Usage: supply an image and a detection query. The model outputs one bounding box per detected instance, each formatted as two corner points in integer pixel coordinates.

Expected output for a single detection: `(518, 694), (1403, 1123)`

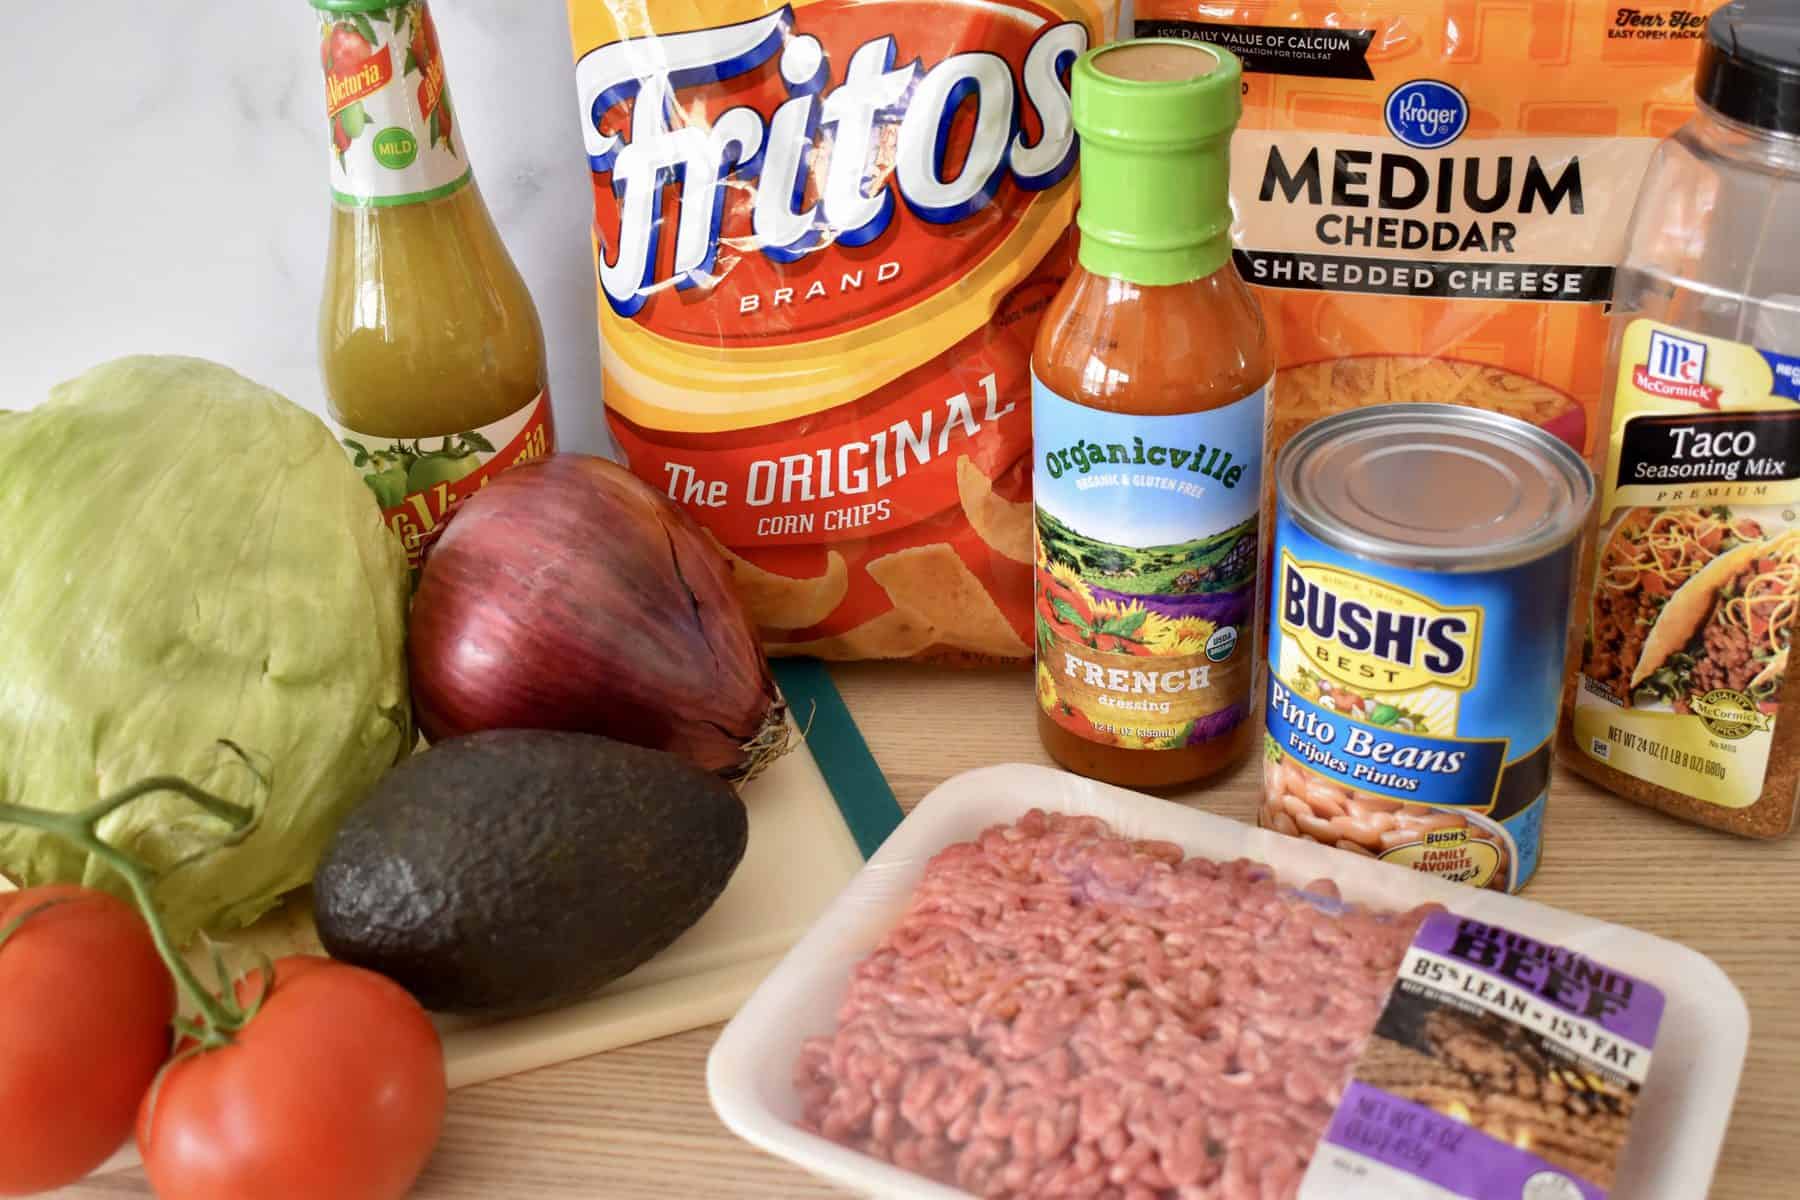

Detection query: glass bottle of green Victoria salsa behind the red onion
(313, 0), (554, 569)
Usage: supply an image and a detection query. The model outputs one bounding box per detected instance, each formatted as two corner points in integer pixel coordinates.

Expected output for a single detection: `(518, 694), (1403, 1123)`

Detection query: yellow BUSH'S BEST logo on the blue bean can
(1280, 554), (1481, 691)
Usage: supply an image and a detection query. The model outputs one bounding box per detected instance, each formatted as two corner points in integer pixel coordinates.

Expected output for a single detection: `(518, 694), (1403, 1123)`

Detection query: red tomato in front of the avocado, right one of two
(137, 957), (446, 1200)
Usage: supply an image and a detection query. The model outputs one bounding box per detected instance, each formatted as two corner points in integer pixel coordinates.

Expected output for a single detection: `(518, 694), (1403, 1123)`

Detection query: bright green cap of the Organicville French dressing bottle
(1071, 38), (1244, 286)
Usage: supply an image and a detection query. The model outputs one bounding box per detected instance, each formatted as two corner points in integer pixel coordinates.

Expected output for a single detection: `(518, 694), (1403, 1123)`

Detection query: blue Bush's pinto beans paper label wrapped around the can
(1260, 504), (1573, 891)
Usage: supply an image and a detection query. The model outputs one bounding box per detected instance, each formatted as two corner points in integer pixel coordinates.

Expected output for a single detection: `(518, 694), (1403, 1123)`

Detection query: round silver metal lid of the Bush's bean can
(1274, 405), (1593, 570)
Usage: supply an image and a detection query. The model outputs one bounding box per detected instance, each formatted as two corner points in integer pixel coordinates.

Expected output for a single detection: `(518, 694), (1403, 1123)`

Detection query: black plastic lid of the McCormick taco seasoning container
(1694, 0), (1800, 137)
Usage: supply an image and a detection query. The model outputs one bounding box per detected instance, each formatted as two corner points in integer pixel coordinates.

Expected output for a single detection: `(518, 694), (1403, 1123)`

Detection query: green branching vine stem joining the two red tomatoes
(0, 775), (266, 1045)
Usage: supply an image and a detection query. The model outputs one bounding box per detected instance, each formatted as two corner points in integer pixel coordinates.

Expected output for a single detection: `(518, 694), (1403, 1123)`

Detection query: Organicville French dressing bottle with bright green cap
(1031, 40), (1273, 788)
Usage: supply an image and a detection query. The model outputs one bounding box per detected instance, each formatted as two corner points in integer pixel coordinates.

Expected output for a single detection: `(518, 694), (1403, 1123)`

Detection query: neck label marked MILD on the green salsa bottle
(319, 0), (472, 207)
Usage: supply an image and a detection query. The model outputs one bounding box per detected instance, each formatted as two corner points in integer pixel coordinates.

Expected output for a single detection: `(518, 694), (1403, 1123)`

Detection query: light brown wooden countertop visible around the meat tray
(63, 666), (1800, 1200)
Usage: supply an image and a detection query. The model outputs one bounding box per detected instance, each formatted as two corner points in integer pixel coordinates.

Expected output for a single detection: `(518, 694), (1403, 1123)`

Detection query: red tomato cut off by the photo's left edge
(0, 885), (175, 1196)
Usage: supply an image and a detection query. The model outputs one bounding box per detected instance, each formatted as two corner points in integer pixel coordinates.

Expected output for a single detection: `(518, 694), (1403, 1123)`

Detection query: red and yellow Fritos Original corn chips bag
(569, 0), (1116, 660)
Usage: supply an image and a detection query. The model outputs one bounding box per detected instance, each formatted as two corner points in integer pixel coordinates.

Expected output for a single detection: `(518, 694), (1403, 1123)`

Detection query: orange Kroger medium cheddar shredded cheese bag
(1136, 0), (1721, 452)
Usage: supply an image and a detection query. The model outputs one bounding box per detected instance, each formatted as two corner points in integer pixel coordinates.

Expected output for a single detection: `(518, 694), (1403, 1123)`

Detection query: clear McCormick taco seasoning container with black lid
(1559, 0), (1800, 837)
